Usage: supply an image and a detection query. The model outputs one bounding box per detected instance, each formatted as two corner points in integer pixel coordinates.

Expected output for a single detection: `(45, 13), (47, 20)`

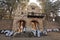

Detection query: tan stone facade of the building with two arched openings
(12, 3), (45, 31)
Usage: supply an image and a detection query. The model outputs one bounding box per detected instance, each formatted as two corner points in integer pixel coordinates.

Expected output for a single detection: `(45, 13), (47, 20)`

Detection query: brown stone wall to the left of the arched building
(0, 20), (13, 30)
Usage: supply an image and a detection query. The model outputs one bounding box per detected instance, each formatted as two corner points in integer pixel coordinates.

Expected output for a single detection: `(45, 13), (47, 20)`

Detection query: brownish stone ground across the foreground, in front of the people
(0, 32), (60, 40)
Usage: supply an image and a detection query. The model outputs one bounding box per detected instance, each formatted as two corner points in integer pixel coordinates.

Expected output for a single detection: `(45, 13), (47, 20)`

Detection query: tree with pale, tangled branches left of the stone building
(0, 0), (18, 18)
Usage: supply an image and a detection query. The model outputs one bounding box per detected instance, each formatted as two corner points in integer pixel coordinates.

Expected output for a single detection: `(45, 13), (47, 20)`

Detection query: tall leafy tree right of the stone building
(45, 0), (60, 19)
